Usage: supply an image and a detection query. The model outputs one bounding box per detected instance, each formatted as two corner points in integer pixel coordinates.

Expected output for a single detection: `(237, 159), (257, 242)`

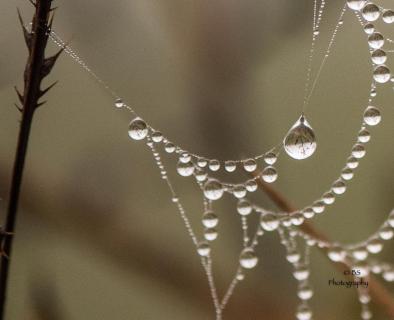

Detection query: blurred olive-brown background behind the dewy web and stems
(0, 0), (394, 320)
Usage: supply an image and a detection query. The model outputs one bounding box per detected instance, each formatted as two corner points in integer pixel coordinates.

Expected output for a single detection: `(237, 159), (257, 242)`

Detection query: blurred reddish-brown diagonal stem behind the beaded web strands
(256, 179), (394, 319)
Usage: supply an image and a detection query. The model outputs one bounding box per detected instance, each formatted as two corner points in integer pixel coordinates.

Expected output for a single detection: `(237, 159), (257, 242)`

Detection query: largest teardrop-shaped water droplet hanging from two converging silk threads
(283, 116), (316, 160)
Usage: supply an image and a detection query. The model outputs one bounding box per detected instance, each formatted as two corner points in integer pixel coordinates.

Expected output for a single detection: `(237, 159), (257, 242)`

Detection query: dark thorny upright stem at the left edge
(0, 0), (60, 320)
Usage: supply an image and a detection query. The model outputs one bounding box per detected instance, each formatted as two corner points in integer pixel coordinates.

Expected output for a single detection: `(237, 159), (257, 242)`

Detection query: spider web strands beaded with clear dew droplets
(44, 1), (393, 320)
